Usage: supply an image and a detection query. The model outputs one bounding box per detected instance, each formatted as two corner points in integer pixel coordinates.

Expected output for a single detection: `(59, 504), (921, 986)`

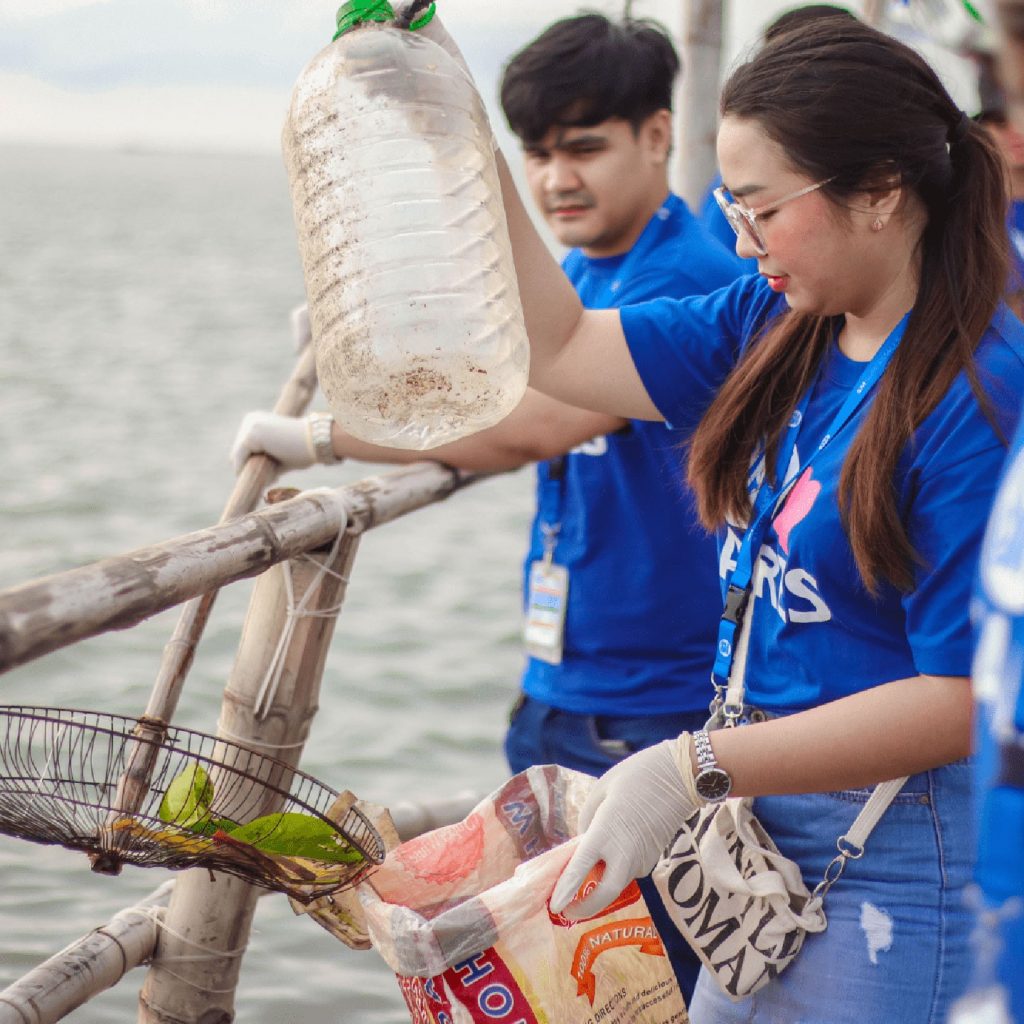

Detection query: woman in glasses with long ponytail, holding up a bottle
(475, 14), (1024, 1024)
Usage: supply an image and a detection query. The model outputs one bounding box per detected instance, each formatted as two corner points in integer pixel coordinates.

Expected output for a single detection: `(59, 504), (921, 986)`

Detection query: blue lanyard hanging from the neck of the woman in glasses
(712, 313), (910, 696)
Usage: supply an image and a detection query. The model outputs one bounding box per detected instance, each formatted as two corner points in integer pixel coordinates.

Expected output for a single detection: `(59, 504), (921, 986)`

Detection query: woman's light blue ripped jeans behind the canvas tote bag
(690, 761), (975, 1024)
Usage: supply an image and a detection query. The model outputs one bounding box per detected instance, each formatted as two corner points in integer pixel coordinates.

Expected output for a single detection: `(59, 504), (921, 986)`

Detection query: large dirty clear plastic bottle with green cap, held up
(283, 0), (528, 450)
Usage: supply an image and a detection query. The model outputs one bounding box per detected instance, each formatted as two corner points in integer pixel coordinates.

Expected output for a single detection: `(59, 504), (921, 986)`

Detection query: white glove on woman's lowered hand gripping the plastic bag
(551, 732), (705, 921)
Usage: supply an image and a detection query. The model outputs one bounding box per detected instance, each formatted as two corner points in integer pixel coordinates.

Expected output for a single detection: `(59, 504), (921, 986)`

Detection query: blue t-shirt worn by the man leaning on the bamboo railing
(522, 196), (739, 715)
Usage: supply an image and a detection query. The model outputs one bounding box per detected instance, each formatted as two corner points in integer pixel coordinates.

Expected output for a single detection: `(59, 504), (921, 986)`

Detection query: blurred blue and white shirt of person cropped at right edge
(974, 413), (1024, 1020)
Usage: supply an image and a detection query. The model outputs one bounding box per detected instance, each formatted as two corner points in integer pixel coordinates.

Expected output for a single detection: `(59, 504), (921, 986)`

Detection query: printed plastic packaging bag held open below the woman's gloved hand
(358, 765), (688, 1024)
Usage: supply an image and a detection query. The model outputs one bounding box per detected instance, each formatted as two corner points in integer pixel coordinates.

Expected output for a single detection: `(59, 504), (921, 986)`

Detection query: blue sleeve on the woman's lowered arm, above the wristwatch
(903, 347), (1024, 676)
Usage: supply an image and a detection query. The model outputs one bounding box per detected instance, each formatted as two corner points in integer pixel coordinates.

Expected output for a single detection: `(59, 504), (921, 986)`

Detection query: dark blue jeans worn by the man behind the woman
(505, 695), (712, 1005)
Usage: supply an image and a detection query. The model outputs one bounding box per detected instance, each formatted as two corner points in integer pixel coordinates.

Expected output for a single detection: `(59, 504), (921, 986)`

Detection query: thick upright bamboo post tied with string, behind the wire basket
(138, 491), (359, 1024)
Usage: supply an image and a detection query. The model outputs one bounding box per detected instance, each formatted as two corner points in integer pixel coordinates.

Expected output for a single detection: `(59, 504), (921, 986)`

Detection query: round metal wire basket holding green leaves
(0, 706), (386, 903)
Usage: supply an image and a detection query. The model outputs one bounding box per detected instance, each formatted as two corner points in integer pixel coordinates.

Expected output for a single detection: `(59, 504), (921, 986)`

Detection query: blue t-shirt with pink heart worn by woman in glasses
(622, 278), (1024, 711)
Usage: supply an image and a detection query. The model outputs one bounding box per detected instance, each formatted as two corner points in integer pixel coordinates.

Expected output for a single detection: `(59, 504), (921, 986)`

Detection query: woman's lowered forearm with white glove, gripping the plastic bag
(551, 676), (971, 920)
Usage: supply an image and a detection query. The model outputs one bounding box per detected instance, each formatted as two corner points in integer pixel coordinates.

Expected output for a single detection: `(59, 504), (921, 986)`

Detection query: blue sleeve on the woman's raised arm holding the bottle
(622, 278), (784, 434)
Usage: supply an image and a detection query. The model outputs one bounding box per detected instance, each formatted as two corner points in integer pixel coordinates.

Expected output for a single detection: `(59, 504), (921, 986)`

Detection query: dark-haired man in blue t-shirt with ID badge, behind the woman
(233, 14), (740, 997)
